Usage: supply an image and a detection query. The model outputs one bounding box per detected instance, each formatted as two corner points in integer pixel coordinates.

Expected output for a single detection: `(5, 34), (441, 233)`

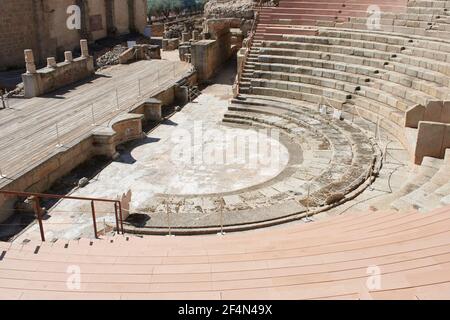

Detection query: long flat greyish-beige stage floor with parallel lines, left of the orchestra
(0, 60), (190, 187)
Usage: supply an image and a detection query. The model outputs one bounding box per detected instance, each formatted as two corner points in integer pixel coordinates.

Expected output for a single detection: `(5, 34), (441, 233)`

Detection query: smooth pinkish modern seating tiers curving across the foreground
(0, 207), (450, 299)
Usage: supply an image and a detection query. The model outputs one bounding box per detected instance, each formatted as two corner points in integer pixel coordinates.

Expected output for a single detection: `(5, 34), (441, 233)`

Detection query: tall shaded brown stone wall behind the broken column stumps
(0, 0), (147, 70)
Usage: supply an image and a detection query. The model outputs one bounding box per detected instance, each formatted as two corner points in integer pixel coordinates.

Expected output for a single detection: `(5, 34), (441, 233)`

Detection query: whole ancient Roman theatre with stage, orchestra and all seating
(0, 0), (450, 299)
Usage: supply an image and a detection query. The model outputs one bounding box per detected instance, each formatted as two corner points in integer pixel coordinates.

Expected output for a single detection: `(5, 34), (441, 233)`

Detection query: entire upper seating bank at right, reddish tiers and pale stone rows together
(236, 0), (450, 215)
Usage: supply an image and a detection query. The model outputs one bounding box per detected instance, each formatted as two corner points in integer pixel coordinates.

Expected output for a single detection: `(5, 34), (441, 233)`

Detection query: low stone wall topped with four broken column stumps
(22, 40), (95, 98)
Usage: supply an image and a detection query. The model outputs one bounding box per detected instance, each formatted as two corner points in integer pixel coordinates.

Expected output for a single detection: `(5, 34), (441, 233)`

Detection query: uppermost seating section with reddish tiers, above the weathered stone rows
(257, 1), (450, 40)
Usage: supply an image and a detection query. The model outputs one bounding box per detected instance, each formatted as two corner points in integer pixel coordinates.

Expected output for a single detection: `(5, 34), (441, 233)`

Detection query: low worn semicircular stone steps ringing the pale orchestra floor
(125, 95), (381, 233)
